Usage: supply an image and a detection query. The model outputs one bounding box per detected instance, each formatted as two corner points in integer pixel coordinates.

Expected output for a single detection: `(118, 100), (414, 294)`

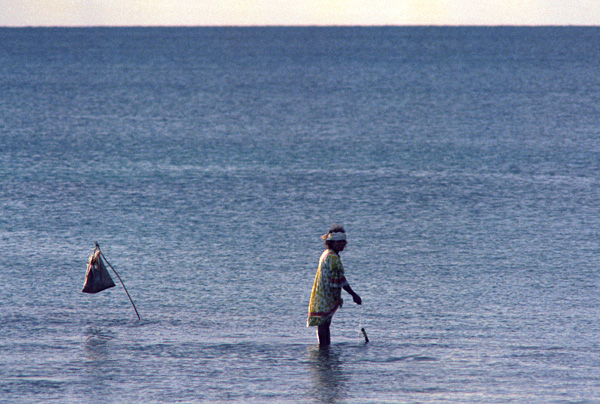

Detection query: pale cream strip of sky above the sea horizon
(0, 0), (600, 26)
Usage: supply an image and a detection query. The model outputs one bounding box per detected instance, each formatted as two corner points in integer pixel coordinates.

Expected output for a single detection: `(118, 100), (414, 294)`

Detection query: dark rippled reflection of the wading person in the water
(308, 345), (348, 403)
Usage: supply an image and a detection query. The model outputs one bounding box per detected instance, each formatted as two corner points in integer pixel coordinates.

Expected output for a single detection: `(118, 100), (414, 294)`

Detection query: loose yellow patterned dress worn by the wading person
(306, 250), (348, 326)
